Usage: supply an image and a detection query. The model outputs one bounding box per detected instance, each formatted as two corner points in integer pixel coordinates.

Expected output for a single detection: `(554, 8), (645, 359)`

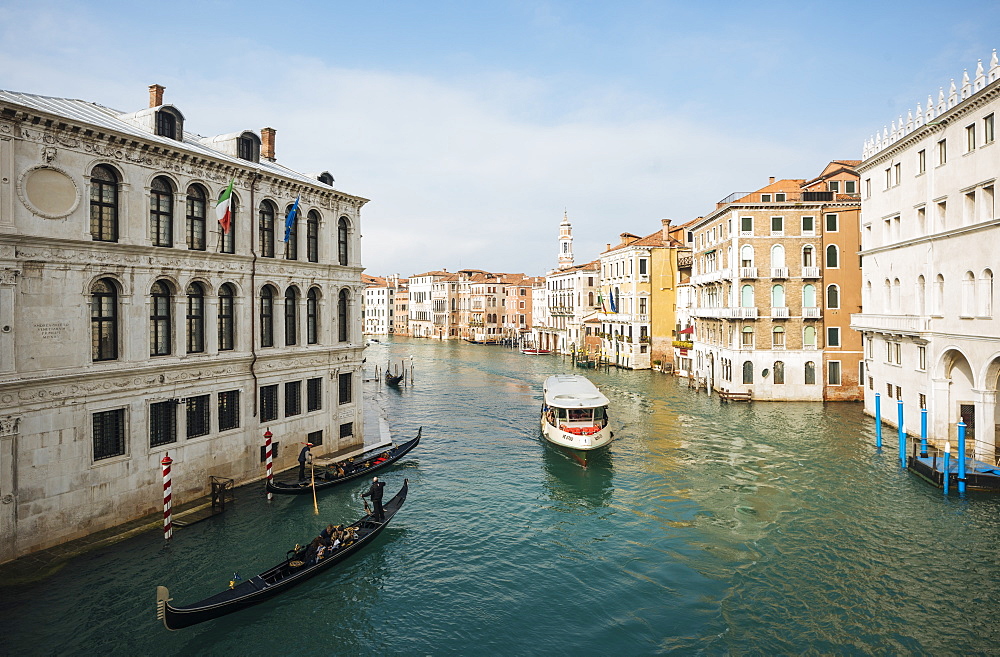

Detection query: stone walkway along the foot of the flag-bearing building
(0, 380), (392, 587)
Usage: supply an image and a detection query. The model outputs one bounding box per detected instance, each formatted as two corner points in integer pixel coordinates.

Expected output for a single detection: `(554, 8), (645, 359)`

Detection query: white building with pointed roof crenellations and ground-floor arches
(852, 51), (1000, 456)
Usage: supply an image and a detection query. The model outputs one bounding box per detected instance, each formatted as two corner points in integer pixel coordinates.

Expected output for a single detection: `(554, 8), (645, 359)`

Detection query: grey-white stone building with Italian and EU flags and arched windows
(0, 85), (366, 561)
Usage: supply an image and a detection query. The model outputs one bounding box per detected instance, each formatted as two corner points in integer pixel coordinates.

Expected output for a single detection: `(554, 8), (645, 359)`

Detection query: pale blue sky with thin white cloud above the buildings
(0, 0), (1000, 276)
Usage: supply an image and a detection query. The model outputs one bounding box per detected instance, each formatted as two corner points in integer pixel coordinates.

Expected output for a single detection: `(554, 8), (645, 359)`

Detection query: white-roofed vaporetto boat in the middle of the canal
(541, 374), (614, 465)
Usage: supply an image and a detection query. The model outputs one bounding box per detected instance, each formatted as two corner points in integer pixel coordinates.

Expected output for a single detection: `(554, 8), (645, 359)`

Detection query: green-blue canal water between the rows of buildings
(0, 340), (1000, 656)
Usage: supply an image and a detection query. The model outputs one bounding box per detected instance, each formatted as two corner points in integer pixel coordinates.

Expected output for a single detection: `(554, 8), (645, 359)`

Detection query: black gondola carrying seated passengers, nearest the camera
(156, 479), (409, 630)
